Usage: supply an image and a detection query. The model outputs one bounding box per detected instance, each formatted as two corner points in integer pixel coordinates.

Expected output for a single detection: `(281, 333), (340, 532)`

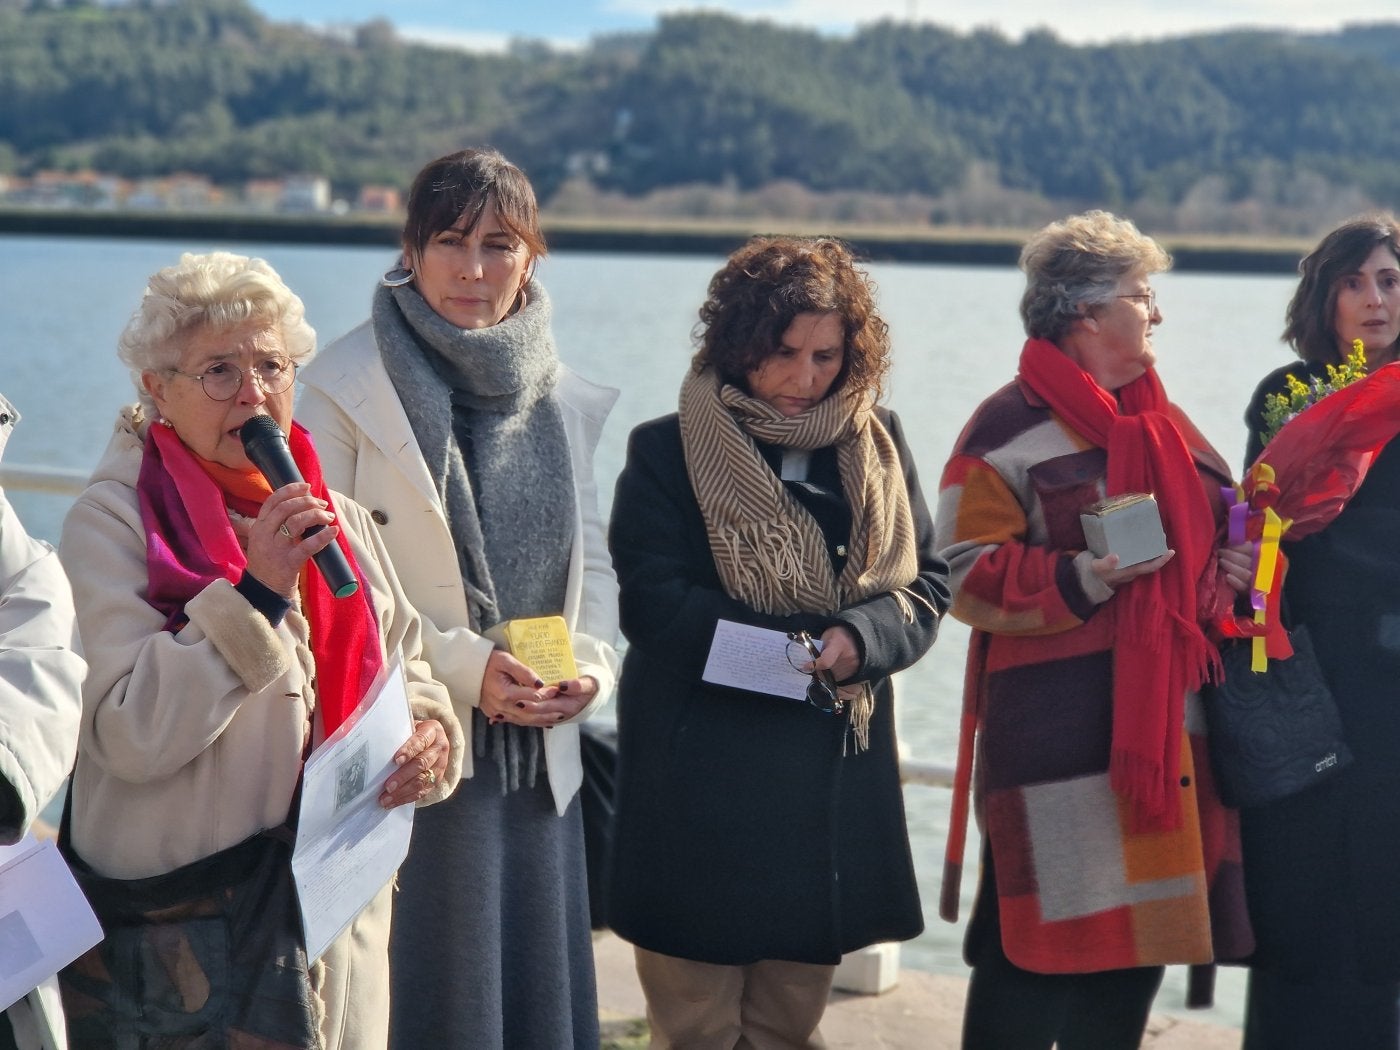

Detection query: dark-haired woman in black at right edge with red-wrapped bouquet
(1242, 216), (1400, 1050)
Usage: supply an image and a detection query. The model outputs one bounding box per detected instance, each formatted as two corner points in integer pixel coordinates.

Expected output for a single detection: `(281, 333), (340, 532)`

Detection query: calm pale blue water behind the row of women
(0, 237), (1294, 1023)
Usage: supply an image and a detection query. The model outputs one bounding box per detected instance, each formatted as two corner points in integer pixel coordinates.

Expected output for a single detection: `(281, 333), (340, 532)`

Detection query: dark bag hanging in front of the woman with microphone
(59, 806), (321, 1050)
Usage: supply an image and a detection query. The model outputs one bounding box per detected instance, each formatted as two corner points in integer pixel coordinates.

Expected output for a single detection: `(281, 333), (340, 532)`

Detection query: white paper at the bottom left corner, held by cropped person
(0, 836), (102, 1011)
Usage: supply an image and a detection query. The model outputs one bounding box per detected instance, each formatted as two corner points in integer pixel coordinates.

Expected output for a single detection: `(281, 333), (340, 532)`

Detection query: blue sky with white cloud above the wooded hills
(252, 0), (1400, 50)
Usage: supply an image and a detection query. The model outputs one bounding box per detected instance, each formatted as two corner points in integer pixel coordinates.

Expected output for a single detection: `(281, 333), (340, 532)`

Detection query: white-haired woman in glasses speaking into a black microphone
(60, 252), (461, 1050)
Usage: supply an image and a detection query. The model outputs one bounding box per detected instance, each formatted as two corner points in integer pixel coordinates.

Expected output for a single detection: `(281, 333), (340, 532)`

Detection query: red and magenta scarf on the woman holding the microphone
(136, 423), (384, 736)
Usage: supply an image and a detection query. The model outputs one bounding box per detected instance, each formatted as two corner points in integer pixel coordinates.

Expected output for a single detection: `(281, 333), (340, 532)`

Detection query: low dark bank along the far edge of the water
(0, 209), (1310, 273)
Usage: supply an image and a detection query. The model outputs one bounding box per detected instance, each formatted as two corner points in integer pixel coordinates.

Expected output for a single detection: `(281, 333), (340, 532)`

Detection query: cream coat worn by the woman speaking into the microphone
(60, 410), (465, 1050)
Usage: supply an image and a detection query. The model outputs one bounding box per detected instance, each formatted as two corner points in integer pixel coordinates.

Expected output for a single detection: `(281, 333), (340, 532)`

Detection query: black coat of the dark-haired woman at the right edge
(1240, 363), (1400, 981)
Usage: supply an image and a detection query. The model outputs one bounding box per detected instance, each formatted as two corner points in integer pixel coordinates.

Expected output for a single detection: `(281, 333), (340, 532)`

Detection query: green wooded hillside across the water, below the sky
(0, 0), (1400, 226)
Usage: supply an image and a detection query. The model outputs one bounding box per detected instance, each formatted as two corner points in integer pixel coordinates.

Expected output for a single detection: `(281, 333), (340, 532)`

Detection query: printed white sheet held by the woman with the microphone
(291, 659), (413, 962)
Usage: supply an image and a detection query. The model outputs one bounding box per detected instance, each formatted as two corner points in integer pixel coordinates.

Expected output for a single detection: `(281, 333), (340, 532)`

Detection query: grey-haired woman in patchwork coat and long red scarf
(935, 211), (1252, 1050)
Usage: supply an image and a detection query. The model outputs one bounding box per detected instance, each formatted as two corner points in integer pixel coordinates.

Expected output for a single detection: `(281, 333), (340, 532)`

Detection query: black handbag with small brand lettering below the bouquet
(1204, 624), (1352, 808)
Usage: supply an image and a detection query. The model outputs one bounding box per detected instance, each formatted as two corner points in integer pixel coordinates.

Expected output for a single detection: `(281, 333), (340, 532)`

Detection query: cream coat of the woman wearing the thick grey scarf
(295, 322), (617, 813)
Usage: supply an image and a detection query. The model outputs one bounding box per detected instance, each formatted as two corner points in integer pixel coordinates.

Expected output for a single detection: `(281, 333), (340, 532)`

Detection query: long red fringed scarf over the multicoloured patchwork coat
(1021, 339), (1219, 830)
